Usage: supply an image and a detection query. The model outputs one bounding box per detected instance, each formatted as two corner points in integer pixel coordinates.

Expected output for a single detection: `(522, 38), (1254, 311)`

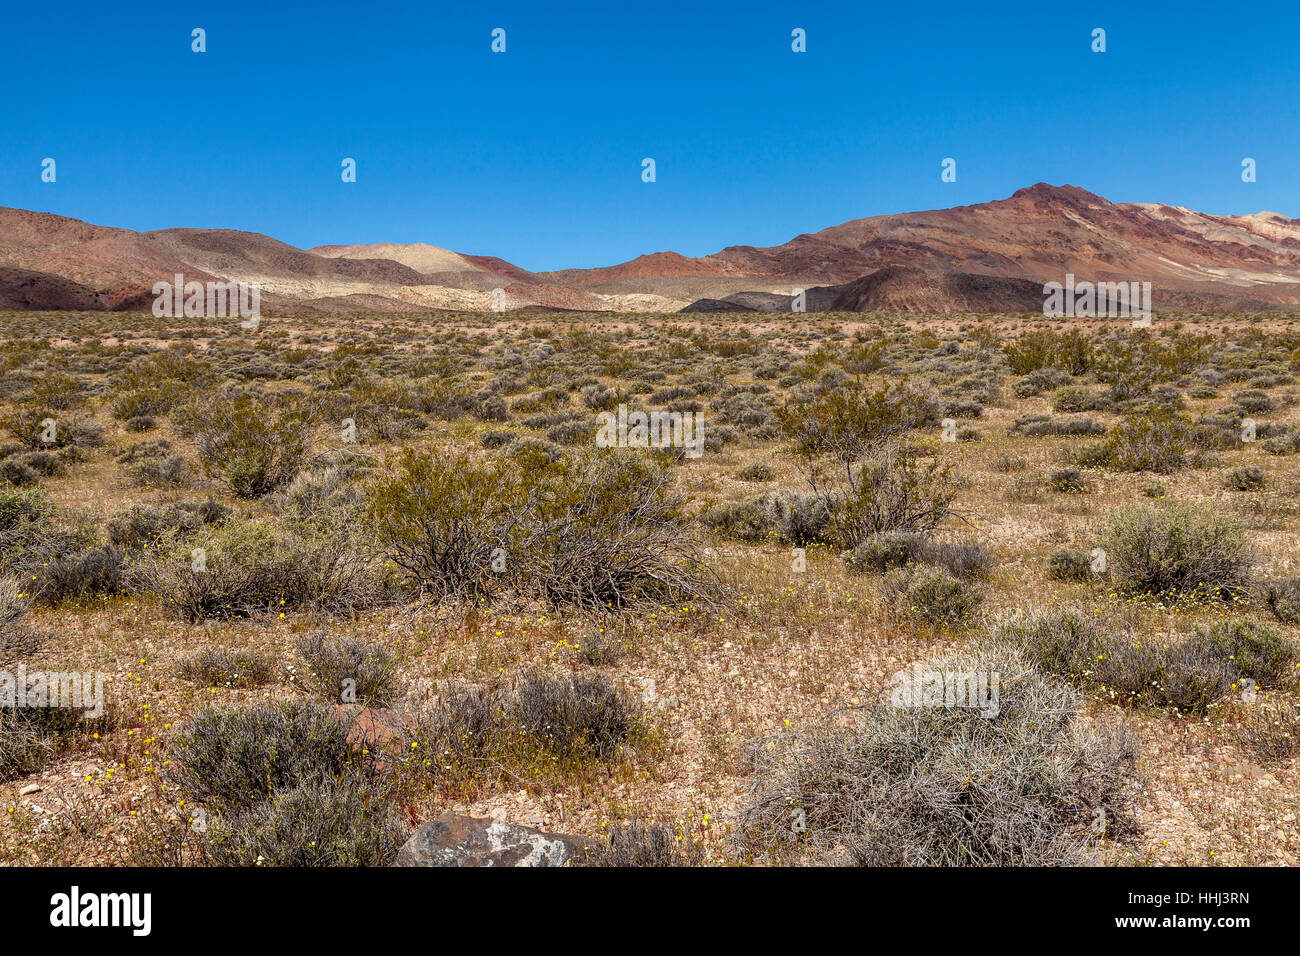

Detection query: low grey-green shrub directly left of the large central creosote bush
(129, 519), (380, 620)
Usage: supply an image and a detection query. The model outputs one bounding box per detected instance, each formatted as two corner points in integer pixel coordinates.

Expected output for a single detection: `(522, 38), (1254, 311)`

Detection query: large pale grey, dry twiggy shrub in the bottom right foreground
(738, 645), (1136, 866)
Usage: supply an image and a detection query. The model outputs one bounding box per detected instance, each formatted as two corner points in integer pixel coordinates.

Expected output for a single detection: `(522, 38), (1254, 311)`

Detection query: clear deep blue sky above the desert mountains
(0, 0), (1300, 269)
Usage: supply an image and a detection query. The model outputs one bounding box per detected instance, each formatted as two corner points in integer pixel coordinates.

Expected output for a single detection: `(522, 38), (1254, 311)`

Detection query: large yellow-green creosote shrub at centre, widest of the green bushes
(369, 450), (716, 609)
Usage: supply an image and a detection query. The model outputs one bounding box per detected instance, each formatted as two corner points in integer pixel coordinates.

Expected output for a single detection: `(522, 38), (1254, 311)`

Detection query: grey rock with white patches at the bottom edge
(394, 813), (593, 866)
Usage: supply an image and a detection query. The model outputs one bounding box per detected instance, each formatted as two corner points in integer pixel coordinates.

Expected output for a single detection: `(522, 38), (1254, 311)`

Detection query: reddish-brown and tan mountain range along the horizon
(0, 183), (1300, 312)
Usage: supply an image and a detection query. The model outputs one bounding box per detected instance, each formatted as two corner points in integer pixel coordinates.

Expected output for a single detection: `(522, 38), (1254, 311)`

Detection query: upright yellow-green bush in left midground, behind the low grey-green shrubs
(177, 393), (319, 498)
